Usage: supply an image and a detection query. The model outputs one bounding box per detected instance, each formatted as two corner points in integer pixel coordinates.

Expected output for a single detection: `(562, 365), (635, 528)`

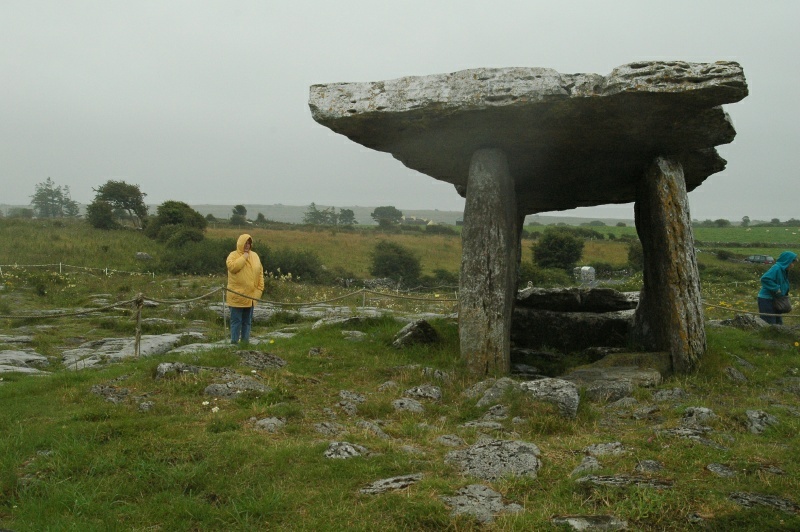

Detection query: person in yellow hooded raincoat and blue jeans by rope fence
(225, 235), (264, 344)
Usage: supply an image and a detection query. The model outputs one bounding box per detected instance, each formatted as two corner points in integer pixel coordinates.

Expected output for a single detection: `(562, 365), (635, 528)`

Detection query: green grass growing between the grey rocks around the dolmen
(0, 220), (800, 531)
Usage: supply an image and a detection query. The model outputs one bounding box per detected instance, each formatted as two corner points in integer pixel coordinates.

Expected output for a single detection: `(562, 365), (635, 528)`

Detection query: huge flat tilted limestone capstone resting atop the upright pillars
(309, 61), (748, 214)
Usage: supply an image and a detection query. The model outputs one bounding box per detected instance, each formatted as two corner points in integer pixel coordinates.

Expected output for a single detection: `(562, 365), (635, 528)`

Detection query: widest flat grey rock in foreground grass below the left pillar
(445, 439), (541, 480)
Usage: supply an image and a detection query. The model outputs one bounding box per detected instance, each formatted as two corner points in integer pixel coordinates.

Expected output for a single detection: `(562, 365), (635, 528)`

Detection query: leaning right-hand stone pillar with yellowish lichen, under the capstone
(634, 157), (706, 373)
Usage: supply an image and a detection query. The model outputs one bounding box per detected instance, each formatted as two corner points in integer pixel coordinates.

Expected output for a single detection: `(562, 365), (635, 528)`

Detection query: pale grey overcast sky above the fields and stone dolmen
(0, 0), (800, 220)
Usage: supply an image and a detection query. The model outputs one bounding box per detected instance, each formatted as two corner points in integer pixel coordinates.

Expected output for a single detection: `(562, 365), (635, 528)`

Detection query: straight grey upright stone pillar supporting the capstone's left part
(458, 149), (520, 375)
